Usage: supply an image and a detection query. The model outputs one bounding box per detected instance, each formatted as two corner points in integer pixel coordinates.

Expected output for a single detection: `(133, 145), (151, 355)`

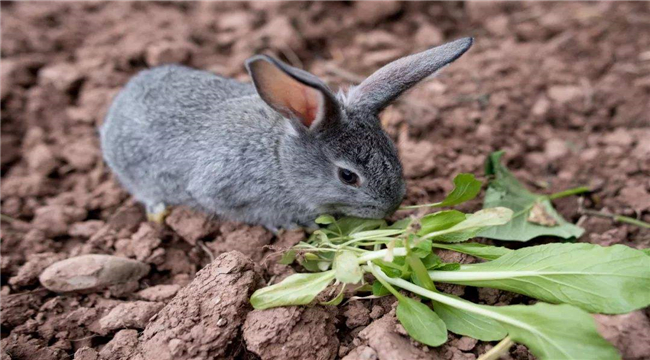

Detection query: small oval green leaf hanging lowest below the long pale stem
(397, 296), (447, 346)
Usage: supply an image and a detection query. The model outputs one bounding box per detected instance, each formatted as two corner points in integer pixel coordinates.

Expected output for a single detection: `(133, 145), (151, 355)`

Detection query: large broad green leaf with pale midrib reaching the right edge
(429, 243), (650, 314)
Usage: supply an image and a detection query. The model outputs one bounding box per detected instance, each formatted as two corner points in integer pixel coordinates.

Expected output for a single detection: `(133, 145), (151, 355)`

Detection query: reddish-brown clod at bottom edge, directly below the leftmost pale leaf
(243, 306), (339, 360)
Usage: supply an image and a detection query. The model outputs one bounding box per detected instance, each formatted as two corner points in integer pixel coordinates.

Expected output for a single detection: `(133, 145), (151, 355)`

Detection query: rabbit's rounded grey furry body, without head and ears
(101, 65), (308, 227)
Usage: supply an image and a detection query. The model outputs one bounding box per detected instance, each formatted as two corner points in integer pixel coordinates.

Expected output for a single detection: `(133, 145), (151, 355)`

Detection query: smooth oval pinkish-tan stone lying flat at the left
(39, 254), (149, 292)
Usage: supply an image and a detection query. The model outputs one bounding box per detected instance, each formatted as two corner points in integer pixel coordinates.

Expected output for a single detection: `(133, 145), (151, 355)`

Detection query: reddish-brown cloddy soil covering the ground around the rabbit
(0, 2), (650, 360)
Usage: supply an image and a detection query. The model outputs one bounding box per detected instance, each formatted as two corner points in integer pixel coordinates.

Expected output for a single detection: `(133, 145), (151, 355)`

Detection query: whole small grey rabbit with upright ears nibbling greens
(100, 38), (472, 229)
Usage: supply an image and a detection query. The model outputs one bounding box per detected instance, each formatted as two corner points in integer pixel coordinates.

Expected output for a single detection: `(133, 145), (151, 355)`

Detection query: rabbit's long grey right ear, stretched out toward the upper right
(346, 37), (473, 113)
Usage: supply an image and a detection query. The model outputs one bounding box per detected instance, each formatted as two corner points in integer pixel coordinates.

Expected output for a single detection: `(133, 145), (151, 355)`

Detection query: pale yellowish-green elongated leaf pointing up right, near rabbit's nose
(423, 207), (512, 242)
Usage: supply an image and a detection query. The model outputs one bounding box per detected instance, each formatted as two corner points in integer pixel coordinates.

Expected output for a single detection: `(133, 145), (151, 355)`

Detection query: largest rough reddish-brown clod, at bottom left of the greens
(141, 251), (261, 360)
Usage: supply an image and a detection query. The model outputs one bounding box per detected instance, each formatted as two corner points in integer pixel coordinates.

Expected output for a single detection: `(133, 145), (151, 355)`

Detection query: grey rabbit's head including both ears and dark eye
(246, 38), (472, 218)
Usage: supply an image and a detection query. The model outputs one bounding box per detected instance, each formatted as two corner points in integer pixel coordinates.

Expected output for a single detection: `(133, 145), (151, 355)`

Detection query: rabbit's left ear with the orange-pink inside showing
(246, 55), (341, 131)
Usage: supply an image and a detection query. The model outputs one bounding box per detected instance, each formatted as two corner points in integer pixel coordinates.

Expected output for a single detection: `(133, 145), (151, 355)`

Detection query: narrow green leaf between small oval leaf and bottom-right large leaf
(433, 295), (508, 341)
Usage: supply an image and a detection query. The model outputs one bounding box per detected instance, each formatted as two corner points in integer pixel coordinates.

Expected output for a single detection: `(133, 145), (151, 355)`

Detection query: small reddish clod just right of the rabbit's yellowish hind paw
(165, 206), (219, 245)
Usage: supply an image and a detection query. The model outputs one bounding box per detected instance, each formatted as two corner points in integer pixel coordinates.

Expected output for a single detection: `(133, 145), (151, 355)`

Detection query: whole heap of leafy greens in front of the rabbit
(251, 152), (650, 360)
